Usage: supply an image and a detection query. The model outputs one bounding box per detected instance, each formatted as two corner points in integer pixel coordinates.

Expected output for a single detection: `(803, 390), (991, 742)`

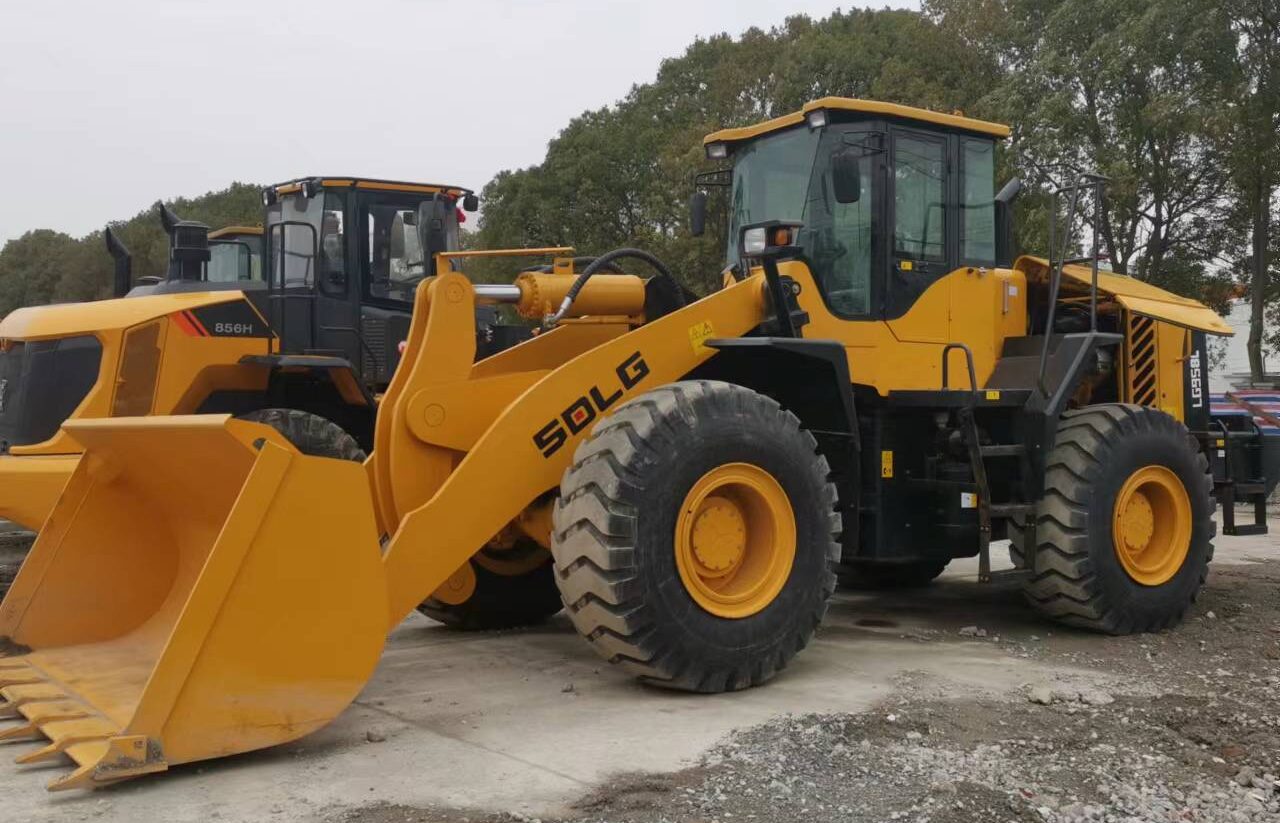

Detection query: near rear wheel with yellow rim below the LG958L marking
(1010, 404), (1217, 635)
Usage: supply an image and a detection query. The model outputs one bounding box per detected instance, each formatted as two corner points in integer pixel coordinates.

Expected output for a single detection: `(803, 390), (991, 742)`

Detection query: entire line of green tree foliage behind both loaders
(0, 0), (1280, 370)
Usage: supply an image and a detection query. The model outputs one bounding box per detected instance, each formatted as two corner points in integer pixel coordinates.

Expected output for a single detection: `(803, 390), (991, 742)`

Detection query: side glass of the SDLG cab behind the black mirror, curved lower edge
(800, 132), (881, 316)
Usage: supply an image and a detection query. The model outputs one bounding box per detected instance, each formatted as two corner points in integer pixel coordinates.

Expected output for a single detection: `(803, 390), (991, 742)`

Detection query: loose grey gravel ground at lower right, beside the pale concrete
(325, 509), (1280, 823)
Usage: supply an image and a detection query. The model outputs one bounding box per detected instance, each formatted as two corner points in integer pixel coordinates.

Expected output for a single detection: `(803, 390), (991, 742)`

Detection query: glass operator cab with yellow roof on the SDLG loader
(700, 97), (1011, 320)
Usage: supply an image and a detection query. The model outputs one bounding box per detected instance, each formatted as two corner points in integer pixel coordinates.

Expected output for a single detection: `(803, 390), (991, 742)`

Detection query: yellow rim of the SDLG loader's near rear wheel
(1111, 466), (1192, 586)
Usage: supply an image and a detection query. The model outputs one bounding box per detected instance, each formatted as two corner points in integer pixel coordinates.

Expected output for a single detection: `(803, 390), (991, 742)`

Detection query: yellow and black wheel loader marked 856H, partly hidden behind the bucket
(0, 178), (509, 530)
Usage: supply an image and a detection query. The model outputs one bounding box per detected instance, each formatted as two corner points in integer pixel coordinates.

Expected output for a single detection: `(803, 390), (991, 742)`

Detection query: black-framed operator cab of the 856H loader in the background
(259, 177), (477, 384)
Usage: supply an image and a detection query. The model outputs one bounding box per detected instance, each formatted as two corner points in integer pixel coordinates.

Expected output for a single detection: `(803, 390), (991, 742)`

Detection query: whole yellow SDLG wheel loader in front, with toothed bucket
(0, 99), (1276, 788)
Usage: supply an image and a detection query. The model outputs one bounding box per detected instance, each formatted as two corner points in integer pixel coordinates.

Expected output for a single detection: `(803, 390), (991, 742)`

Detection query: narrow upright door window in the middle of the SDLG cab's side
(893, 133), (947, 262)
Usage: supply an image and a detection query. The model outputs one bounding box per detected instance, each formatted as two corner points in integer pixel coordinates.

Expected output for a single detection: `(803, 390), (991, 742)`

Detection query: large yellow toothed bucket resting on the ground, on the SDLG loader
(0, 416), (388, 788)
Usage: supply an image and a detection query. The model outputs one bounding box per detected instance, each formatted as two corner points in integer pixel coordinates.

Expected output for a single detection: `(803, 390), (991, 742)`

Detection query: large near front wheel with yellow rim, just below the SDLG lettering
(552, 380), (840, 692)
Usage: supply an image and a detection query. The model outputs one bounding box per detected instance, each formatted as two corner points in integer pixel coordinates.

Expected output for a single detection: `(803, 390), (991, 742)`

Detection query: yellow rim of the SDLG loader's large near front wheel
(676, 463), (796, 618)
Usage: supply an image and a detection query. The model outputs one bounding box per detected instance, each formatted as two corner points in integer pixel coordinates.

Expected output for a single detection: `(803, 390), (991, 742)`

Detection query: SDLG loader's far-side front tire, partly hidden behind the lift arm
(417, 540), (563, 631)
